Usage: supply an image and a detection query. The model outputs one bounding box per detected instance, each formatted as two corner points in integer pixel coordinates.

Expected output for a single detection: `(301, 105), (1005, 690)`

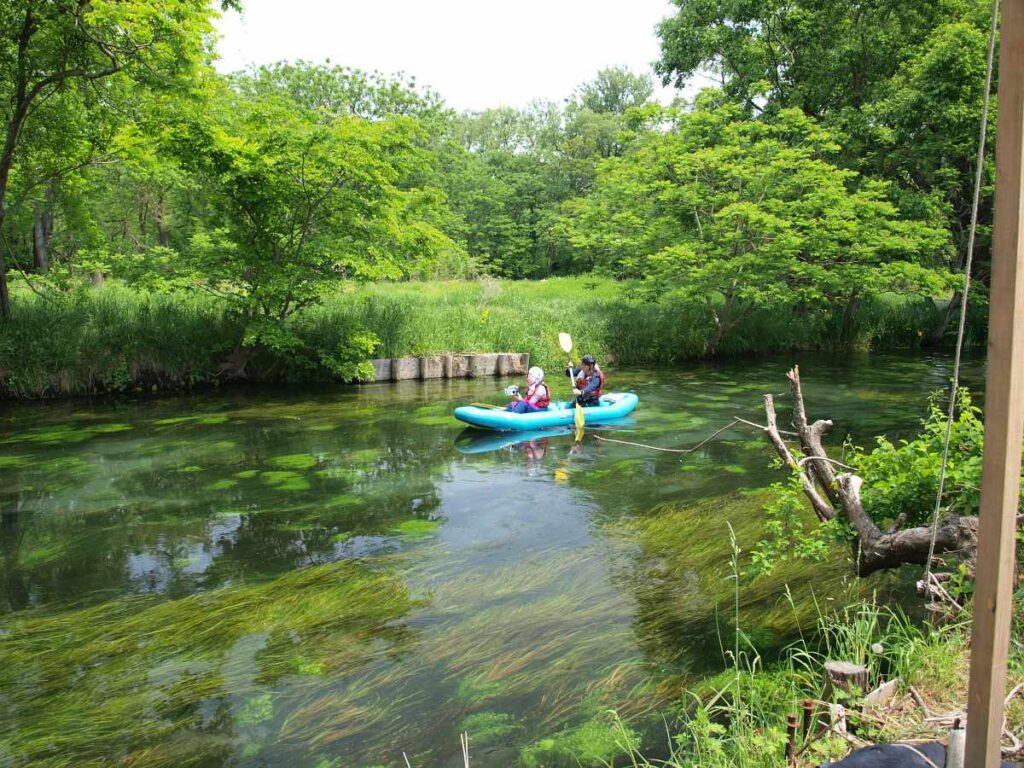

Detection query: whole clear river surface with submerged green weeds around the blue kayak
(0, 355), (981, 768)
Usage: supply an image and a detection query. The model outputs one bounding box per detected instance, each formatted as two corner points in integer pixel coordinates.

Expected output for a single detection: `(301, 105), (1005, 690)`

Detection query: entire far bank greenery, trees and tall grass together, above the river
(0, 0), (994, 397)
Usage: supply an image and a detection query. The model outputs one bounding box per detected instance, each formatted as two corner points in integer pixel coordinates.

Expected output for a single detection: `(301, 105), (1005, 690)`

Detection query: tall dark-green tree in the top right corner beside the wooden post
(655, 0), (994, 342)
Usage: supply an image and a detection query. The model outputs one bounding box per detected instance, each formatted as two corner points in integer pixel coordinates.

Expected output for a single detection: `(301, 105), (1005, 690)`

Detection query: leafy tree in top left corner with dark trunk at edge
(0, 0), (234, 317)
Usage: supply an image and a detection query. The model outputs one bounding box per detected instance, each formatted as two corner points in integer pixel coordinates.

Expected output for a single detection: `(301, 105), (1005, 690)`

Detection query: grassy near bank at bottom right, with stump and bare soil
(618, 603), (1024, 768)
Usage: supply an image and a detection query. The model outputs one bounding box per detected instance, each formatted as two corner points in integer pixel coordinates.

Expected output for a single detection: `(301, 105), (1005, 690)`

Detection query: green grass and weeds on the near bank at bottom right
(614, 600), (968, 768)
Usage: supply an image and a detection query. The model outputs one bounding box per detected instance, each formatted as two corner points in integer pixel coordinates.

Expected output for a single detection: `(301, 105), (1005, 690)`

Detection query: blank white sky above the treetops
(218, 0), (696, 111)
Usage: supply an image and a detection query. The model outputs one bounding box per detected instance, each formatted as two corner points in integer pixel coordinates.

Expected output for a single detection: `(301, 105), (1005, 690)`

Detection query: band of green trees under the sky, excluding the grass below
(0, 0), (990, 364)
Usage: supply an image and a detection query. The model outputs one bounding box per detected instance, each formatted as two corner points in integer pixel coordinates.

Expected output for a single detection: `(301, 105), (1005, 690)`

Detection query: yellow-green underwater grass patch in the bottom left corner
(0, 562), (415, 765)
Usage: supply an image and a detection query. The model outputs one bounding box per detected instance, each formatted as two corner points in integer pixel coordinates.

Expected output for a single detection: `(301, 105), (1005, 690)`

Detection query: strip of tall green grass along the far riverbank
(0, 278), (974, 397)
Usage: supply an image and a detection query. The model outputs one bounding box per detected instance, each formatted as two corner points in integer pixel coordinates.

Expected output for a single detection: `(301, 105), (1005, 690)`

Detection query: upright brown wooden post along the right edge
(965, 0), (1024, 768)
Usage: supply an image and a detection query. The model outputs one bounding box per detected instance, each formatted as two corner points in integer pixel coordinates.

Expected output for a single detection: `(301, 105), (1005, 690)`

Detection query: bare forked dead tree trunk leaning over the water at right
(764, 367), (978, 575)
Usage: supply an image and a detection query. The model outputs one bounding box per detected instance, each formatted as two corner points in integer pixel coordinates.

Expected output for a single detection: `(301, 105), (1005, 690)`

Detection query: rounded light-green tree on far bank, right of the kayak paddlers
(567, 95), (947, 354)
